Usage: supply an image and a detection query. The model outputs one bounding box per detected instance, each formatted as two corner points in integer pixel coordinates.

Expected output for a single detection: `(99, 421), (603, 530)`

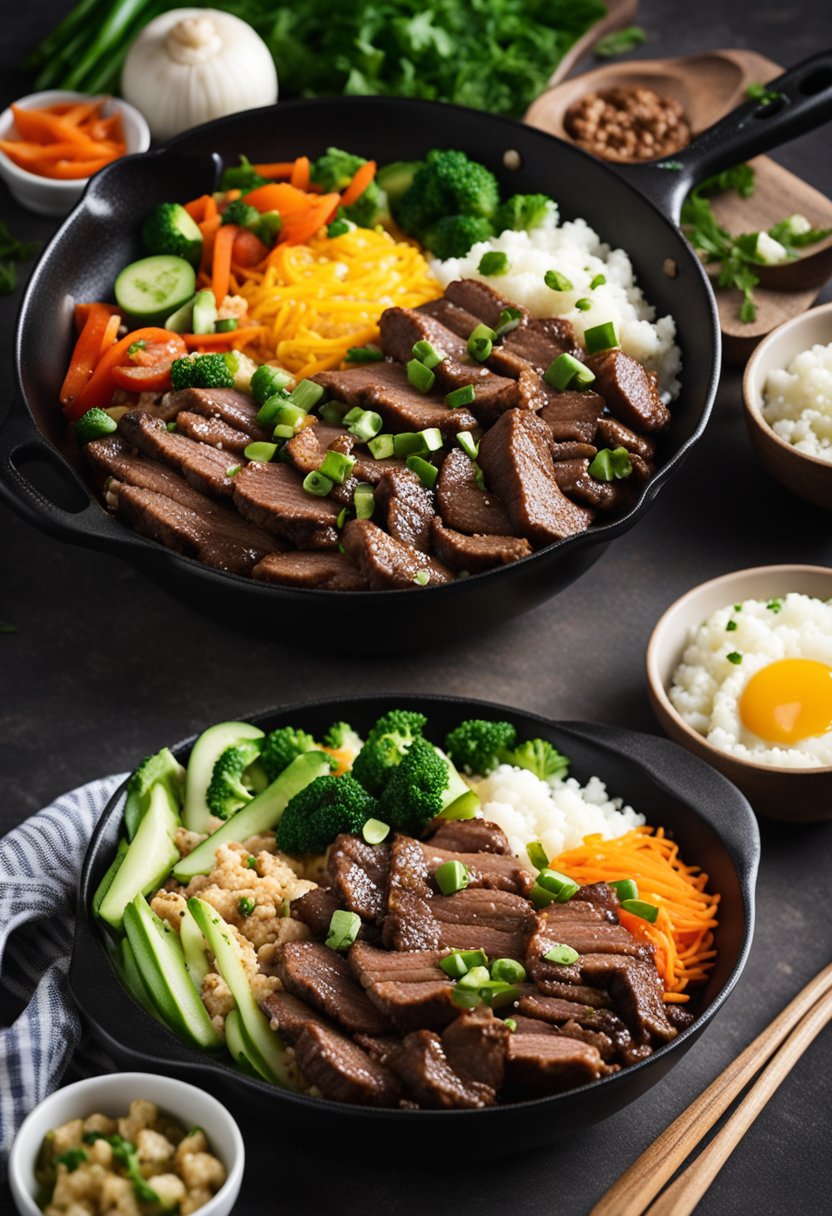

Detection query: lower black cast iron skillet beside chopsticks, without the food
(69, 697), (760, 1159)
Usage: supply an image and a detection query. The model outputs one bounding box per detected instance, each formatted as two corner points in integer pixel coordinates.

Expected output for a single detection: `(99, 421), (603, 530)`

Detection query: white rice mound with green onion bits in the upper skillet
(431, 203), (681, 401)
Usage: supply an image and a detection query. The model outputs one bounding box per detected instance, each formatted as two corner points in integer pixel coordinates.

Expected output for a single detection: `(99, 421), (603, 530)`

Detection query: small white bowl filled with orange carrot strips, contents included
(0, 89), (150, 215)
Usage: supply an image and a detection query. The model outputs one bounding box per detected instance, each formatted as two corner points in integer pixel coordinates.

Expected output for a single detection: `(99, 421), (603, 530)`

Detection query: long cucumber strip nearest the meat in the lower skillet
(187, 899), (295, 1088)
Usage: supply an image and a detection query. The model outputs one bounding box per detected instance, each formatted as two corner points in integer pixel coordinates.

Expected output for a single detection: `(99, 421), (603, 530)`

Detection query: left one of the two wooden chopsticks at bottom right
(590, 963), (832, 1216)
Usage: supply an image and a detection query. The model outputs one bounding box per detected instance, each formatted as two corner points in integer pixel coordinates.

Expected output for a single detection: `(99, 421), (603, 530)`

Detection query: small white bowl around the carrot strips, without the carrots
(0, 89), (150, 215)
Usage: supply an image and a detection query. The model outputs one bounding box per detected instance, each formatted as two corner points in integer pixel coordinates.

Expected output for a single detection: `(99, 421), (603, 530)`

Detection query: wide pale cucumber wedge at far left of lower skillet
(96, 784), (179, 929)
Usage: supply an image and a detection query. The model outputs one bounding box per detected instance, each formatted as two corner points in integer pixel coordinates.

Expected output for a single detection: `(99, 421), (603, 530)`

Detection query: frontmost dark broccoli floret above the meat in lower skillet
(277, 776), (376, 857)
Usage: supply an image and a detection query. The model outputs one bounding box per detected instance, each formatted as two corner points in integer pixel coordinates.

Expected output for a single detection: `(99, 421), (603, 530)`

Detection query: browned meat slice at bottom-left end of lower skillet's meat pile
(294, 1023), (399, 1107)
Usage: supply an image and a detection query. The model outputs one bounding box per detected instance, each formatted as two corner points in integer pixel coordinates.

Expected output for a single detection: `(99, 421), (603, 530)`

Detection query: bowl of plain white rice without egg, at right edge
(742, 304), (832, 510)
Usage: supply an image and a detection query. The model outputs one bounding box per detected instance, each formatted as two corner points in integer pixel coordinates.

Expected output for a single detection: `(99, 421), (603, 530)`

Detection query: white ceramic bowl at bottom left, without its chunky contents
(9, 1073), (246, 1216)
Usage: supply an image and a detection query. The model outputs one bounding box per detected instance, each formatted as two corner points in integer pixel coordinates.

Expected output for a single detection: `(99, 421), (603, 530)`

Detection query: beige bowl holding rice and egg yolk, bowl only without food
(646, 565), (832, 823)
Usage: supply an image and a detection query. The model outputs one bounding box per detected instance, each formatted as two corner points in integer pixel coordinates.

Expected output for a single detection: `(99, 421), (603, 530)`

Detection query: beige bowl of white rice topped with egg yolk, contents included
(647, 565), (832, 822)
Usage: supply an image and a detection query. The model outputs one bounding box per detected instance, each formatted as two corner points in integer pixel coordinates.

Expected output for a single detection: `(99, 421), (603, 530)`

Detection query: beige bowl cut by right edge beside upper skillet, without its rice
(742, 304), (832, 511)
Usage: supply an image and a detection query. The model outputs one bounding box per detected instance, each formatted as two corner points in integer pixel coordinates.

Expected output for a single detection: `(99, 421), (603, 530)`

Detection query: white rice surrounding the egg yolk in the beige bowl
(669, 592), (832, 769)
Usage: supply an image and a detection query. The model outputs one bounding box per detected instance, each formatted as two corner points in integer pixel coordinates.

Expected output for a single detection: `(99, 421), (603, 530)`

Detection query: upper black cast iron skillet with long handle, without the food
(0, 52), (832, 649)
